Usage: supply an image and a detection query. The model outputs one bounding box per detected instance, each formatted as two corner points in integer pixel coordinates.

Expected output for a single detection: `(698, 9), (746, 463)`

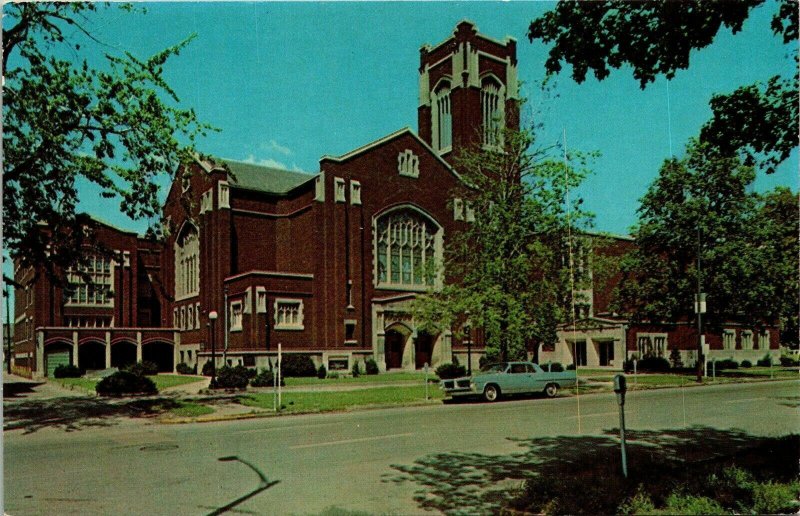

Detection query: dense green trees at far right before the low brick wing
(616, 142), (800, 336)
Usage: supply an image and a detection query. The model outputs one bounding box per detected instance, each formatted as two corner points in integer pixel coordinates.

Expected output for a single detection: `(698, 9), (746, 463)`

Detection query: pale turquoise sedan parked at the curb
(440, 362), (577, 401)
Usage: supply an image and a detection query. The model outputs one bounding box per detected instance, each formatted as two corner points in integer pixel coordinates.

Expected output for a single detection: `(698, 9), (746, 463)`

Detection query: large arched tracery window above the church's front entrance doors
(375, 208), (442, 290)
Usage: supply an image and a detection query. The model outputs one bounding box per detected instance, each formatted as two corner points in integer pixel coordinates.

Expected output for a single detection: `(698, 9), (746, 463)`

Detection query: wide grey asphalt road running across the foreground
(4, 381), (800, 516)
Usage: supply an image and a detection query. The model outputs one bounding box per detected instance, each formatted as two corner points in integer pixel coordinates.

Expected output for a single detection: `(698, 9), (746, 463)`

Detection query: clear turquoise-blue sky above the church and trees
(3, 2), (798, 286)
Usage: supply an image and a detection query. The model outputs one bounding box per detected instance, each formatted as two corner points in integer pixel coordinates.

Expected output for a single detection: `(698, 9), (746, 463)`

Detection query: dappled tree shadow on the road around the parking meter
(383, 426), (800, 514)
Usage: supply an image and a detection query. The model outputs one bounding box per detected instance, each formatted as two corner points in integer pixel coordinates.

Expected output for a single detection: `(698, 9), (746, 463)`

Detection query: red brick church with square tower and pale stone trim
(13, 21), (777, 377)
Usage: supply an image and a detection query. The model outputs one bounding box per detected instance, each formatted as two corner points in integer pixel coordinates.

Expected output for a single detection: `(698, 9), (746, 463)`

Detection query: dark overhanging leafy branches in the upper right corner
(528, 0), (798, 173)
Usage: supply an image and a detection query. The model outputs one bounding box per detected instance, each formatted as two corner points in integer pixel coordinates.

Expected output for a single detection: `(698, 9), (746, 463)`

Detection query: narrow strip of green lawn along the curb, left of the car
(240, 385), (442, 413)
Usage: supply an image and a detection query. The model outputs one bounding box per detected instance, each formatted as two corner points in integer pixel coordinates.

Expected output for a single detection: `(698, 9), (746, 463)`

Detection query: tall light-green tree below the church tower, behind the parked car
(415, 127), (588, 360)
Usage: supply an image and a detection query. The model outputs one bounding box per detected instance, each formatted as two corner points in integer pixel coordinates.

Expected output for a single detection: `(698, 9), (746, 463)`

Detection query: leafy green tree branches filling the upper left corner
(3, 2), (209, 274)
